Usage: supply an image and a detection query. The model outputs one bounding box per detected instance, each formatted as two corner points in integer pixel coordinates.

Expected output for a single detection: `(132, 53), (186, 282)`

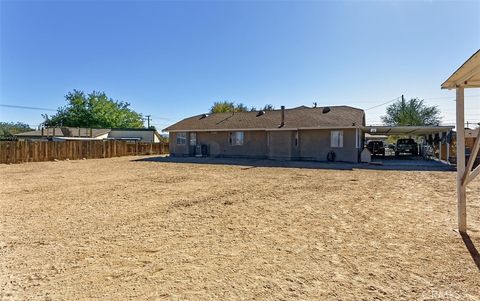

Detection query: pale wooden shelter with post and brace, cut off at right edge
(441, 50), (480, 234)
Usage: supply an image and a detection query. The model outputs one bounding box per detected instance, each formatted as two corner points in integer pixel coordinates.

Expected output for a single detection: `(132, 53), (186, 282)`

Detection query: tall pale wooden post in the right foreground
(456, 87), (467, 233)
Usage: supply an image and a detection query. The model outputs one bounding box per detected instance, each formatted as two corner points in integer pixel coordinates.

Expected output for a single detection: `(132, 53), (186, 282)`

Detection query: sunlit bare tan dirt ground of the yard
(0, 157), (480, 300)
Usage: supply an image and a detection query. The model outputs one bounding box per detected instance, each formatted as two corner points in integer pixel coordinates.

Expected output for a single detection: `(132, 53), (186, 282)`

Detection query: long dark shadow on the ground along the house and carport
(133, 156), (455, 171)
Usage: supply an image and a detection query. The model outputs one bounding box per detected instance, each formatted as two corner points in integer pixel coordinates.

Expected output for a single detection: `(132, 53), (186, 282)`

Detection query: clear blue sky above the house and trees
(0, 0), (480, 128)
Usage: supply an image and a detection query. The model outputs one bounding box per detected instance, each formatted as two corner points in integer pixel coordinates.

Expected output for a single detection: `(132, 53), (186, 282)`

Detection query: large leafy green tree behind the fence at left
(43, 90), (143, 128)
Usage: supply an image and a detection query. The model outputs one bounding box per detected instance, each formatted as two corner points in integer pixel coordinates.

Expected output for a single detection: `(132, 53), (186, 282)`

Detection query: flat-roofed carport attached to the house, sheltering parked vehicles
(365, 126), (454, 161)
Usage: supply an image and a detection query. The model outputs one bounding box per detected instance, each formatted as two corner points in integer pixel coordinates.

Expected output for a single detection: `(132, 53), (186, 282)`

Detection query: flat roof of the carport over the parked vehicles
(365, 126), (455, 136)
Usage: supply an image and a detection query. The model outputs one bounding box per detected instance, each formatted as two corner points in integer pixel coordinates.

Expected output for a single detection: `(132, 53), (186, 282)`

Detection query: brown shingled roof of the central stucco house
(164, 106), (365, 132)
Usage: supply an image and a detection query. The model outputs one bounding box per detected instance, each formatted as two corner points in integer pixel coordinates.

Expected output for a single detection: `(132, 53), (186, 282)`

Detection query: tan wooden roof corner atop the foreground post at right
(442, 50), (480, 89)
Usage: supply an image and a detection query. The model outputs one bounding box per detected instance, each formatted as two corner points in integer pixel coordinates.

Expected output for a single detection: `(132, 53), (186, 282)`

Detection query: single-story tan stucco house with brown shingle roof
(164, 106), (365, 162)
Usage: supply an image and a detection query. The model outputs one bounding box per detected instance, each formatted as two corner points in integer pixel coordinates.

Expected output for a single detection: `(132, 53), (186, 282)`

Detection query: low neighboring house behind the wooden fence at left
(15, 127), (160, 142)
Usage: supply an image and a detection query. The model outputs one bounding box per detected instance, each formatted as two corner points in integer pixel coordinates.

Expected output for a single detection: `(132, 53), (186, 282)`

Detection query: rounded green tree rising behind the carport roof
(382, 98), (441, 126)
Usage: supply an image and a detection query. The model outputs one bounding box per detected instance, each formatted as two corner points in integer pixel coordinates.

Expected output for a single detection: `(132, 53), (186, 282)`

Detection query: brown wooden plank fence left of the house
(0, 140), (168, 163)
